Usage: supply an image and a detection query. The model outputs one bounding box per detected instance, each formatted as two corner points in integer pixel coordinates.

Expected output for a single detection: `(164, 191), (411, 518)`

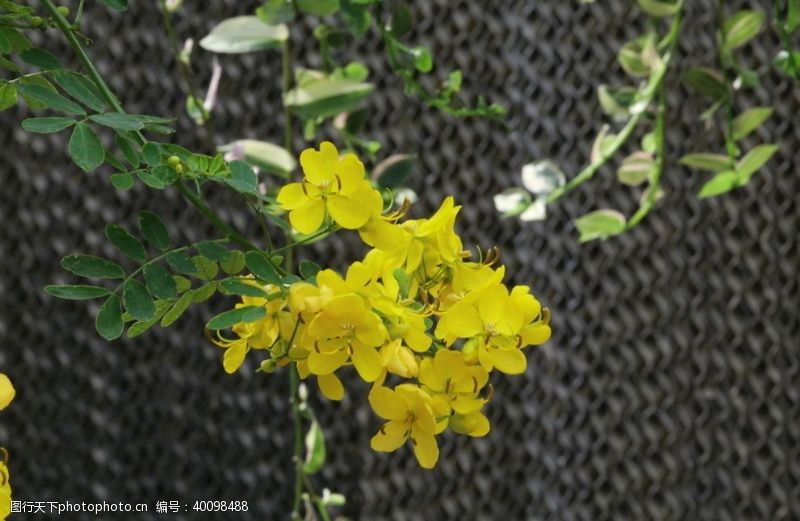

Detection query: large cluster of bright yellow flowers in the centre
(209, 143), (550, 468)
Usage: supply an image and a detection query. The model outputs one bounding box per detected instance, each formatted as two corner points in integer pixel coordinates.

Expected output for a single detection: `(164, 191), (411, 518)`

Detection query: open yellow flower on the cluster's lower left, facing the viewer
(307, 293), (386, 382)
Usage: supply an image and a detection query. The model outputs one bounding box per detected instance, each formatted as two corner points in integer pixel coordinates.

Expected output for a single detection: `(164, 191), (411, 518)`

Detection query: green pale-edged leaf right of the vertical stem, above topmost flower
(284, 80), (375, 119)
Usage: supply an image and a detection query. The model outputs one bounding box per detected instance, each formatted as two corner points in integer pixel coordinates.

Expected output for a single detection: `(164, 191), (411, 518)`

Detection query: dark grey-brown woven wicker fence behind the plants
(0, 0), (800, 521)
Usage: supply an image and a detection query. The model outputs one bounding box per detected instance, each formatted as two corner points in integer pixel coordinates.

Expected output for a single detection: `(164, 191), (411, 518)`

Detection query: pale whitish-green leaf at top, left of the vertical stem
(200, 16), (289, 54)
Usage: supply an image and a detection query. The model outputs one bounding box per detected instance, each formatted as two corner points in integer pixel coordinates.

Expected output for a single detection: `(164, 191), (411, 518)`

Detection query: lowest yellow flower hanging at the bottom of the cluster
(369, 384), (447, 469)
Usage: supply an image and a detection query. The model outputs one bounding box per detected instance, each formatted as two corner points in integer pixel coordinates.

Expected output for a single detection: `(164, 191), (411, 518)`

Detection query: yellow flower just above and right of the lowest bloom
(419, 349), (489, 414)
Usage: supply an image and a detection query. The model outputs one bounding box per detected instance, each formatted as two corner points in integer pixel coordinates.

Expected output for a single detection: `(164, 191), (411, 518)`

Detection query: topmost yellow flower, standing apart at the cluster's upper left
(278, 141), (383, 234)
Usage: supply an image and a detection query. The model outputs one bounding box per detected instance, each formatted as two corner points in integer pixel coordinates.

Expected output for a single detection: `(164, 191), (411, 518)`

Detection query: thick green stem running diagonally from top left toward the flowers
(42, 0), (258, 250)
